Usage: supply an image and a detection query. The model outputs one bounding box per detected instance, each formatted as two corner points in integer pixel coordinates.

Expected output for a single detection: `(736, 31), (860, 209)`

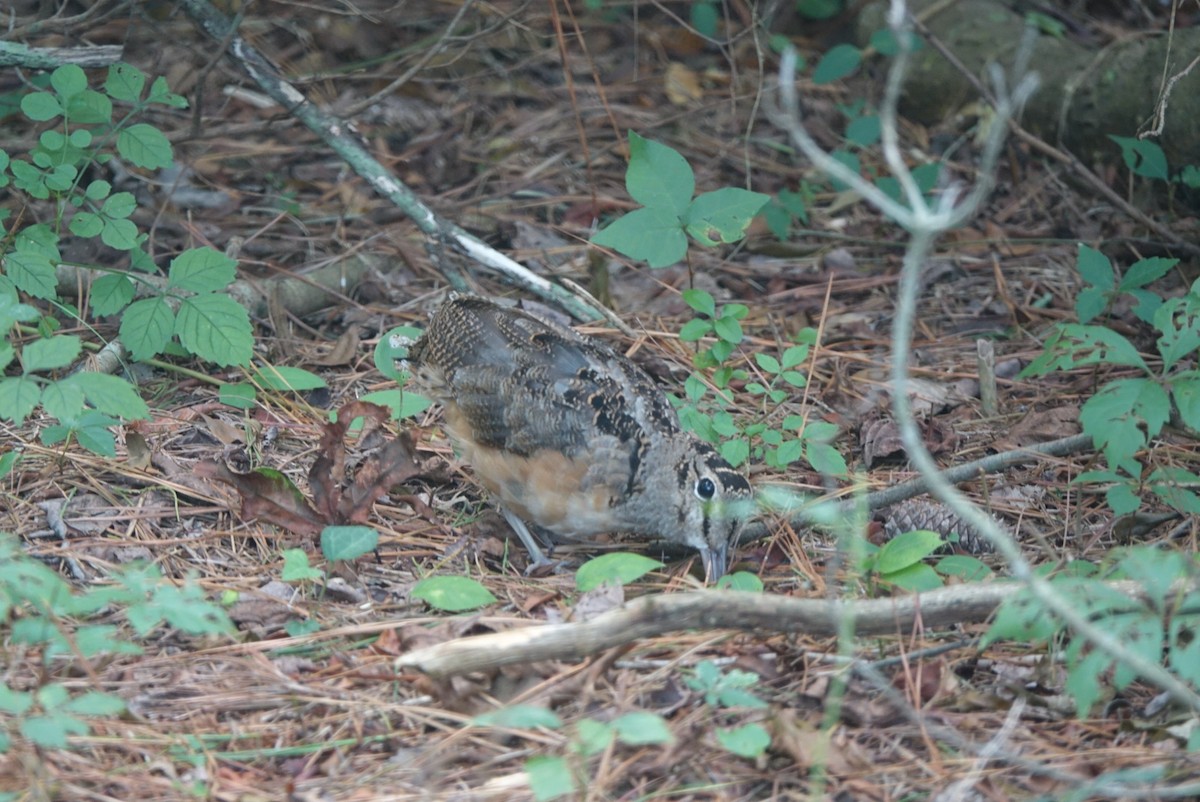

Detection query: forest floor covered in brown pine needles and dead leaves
(0, 1), (1195, 800)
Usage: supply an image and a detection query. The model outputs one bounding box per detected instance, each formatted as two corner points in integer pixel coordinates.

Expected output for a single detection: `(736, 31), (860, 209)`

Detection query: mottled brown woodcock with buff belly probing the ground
(409, 297), (751, 579)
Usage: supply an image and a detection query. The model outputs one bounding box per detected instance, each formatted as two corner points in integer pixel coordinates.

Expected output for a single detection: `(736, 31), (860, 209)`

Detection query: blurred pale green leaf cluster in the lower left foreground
(0, 533), (234, 754)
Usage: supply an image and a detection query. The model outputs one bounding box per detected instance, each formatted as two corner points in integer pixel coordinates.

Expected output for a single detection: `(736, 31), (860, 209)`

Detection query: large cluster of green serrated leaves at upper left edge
(0, 64), (252, 456)
